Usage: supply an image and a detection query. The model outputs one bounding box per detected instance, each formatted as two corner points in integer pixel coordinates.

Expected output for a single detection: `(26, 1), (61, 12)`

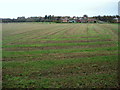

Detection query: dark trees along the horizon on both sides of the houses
(2, 15), (120, 23)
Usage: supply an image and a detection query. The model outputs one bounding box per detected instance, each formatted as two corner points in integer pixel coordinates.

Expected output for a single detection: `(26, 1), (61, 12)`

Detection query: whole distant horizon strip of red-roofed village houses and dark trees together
(2, 15), (120, 23)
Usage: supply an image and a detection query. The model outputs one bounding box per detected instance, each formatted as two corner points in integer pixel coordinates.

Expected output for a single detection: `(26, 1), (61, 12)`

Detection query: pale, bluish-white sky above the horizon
(0, 0), (119, 18)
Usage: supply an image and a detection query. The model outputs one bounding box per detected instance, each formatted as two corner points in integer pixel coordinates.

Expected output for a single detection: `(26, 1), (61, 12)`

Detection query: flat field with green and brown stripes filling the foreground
(2, 23), (119, 88)
